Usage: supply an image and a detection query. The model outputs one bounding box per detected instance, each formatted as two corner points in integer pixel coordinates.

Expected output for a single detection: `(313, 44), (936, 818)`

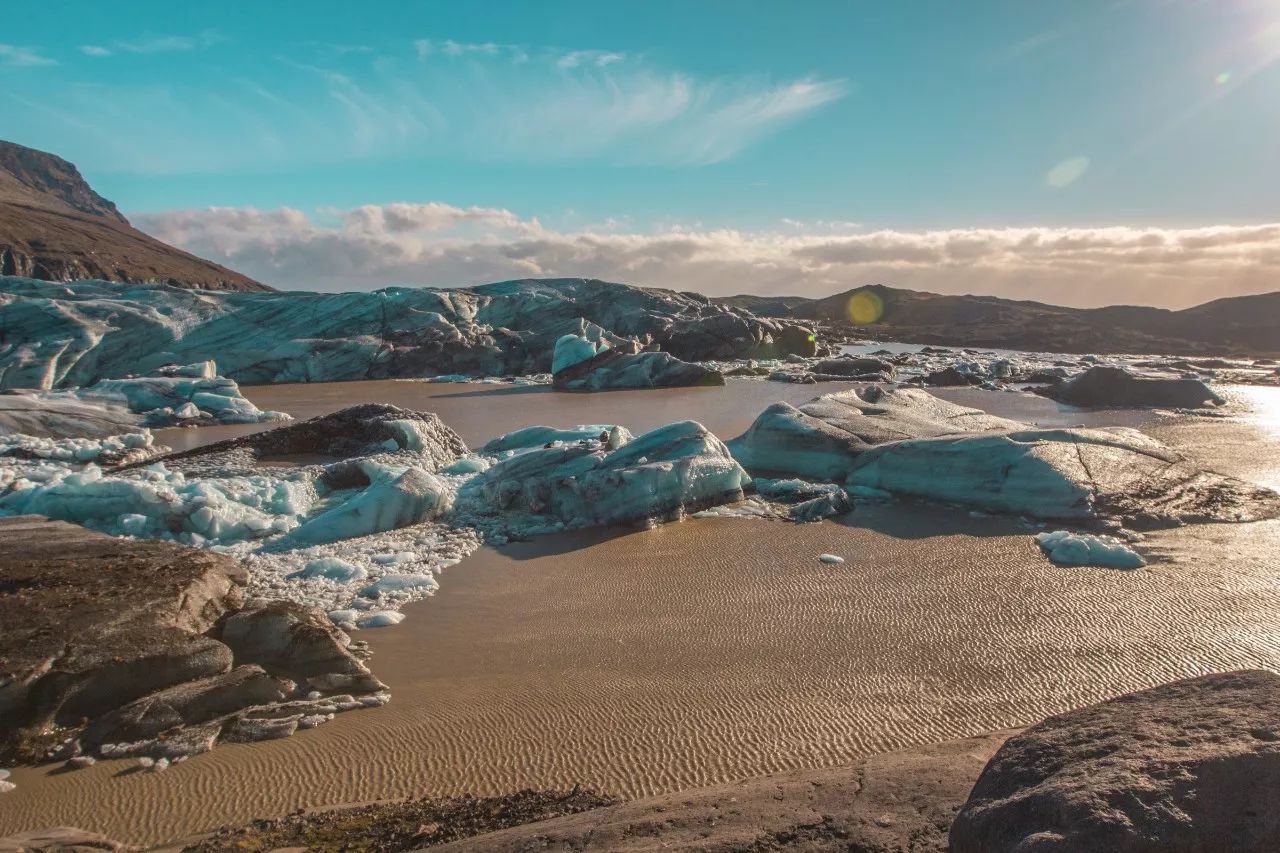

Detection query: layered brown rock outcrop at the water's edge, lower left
(0, 516), (387, 762)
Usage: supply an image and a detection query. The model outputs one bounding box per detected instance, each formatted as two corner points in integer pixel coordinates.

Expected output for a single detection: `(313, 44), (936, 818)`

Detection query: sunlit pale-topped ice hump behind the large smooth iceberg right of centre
(728, 386), (1020, 482)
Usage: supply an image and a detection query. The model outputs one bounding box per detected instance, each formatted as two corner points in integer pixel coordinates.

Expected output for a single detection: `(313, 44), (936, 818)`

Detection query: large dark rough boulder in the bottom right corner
(950, 671), (1280, 853)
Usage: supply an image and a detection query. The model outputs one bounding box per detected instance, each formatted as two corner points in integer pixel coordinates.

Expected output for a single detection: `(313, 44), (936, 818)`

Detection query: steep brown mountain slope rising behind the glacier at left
(0, 141), (271, 291)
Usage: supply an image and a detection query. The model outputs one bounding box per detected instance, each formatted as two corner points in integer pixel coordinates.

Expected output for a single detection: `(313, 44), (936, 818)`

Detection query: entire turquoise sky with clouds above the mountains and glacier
(0, 0), (1280, 307)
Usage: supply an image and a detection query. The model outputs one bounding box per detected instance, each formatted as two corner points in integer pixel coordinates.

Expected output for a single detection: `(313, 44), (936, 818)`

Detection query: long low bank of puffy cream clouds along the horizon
(133, 202), (1280, 307)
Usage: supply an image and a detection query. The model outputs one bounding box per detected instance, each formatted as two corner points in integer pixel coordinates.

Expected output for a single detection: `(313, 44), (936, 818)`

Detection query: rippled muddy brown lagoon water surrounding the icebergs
(0, 382), (1280, 843)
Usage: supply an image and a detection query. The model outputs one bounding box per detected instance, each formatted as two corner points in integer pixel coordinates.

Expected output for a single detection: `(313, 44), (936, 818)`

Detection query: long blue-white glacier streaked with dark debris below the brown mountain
(0, 277), (817, 389)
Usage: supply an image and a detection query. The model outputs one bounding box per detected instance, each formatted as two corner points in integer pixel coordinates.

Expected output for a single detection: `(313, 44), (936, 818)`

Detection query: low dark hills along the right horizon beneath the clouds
(714, 284), (1280, 356)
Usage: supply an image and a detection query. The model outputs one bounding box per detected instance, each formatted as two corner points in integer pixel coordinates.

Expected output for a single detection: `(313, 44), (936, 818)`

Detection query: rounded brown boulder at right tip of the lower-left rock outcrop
(218, 601), (387, 693)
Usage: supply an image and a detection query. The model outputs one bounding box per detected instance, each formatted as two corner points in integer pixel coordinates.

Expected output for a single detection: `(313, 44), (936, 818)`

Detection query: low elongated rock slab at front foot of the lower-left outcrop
(81, 665), (293, 749)
